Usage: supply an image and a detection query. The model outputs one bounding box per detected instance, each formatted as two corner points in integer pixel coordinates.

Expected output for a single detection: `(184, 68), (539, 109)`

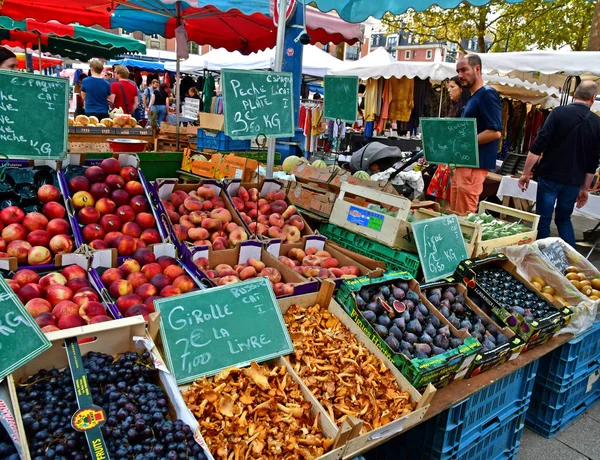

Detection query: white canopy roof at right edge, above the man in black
(480, 51), (600, 87)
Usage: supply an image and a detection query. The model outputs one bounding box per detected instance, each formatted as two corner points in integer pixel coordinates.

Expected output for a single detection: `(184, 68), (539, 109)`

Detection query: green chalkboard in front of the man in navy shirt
(421, 118), (479, 168)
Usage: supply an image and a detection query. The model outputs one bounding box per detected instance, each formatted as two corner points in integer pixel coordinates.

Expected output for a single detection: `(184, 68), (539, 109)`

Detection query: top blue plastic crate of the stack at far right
(537, 321), (600, 392)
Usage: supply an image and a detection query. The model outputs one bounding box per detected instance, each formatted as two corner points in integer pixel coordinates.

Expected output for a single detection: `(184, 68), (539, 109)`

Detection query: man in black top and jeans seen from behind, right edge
(519, 81), (600, 247)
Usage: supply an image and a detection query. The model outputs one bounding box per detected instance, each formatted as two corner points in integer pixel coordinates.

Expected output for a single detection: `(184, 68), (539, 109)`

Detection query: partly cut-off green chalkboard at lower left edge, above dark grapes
(0, 276), (50, 379)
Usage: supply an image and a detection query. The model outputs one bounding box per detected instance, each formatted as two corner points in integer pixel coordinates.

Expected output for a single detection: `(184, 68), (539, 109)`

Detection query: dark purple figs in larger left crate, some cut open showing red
(356, 281), (462, 359)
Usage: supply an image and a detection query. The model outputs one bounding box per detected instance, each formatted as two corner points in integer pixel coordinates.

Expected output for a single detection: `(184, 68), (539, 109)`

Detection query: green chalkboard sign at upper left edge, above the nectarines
(0, 70), (69, 160)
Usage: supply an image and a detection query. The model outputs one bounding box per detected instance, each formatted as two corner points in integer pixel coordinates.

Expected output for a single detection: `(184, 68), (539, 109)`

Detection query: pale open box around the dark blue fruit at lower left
(7, 316), (214, 460)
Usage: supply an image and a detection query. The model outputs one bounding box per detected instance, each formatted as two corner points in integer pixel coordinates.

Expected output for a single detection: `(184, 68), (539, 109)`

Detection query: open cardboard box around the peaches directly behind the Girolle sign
(186, 240), (319, 298)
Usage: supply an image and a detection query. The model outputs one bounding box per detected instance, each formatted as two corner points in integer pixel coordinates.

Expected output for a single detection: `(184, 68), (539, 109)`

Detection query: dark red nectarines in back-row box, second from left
(69, 158), (162, 256)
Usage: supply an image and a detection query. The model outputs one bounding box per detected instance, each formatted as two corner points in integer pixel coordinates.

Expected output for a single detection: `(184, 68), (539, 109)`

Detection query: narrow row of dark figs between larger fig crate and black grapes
(422, 286), (508, 351)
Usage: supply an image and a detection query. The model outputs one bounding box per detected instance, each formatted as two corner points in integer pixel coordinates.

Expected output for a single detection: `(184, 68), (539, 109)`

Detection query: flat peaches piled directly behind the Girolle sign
(194, 257), (295, 297)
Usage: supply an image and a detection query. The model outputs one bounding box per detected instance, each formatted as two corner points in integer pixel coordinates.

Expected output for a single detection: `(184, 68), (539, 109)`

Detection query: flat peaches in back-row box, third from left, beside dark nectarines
(161, 185), (248, 251)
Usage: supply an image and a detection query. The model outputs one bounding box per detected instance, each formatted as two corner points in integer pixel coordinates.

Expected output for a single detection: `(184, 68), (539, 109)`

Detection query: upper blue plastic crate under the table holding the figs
(406, 361), (537, 456)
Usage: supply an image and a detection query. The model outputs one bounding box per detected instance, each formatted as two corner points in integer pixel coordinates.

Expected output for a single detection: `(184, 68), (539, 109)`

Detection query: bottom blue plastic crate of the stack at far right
(526, 364), (600, 438)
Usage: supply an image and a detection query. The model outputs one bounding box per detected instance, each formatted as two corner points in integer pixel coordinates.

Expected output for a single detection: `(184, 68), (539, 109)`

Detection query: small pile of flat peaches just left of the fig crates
(279, 246), (360, 279)
